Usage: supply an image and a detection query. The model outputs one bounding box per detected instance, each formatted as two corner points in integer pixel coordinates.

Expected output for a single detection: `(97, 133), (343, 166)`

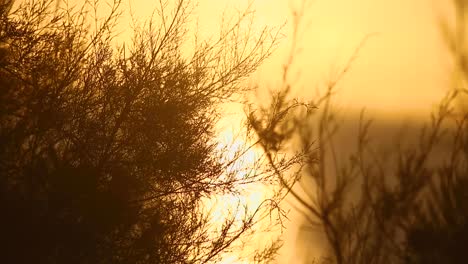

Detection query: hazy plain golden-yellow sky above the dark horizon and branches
(86, 0), (450, 116)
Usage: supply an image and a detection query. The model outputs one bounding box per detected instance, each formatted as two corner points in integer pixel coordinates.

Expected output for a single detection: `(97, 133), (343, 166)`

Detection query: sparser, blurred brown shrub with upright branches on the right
(250, 1), (468, 264)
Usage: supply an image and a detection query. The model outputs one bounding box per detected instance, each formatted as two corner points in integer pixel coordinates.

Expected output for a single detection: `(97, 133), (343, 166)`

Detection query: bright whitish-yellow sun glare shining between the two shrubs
(205, 104), (278, 263)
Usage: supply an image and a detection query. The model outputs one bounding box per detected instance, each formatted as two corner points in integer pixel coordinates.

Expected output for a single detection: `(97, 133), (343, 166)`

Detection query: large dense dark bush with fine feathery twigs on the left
(0, 0), (294, 263)
